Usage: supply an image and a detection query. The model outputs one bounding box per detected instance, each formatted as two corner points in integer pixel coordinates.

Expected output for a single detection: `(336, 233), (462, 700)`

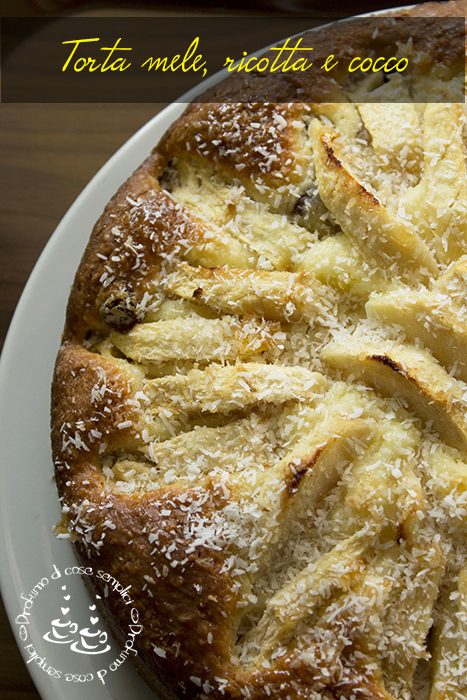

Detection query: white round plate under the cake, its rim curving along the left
(0, 104), (184, 700)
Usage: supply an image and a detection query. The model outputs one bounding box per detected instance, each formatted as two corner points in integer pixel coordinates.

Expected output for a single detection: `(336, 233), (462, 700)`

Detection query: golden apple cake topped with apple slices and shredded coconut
(52, 3), (467, 700)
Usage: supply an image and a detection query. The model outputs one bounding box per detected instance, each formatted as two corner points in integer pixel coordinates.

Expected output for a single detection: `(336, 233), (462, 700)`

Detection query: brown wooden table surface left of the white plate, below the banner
(0, 104), (165, 700)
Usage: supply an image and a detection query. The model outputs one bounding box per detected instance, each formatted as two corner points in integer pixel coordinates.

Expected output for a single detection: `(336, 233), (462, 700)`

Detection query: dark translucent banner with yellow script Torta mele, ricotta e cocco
(1, 16), (465, 103)
